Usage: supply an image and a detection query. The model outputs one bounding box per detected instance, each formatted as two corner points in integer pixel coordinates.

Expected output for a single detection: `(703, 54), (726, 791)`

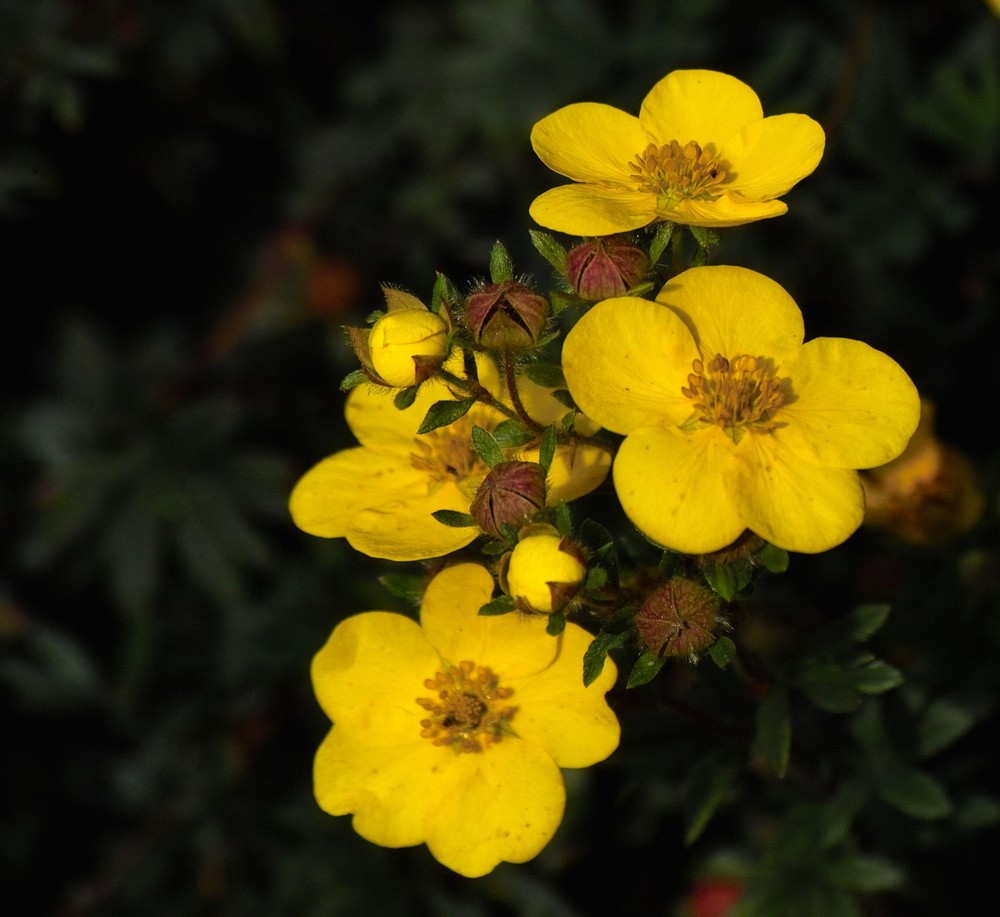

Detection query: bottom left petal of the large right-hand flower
(613, 427), (746, 554)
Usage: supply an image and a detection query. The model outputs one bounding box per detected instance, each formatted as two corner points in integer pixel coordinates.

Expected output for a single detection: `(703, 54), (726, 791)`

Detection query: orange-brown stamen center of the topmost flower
(628, 140), (730, 210)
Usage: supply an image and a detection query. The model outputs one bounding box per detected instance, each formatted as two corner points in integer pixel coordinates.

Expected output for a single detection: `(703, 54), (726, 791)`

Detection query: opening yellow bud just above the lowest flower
(505, 525), (587, 614)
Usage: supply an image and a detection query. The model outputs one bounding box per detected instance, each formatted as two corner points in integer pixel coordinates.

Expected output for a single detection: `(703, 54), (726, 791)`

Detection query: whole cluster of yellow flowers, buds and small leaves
(290, 70), (920, 876)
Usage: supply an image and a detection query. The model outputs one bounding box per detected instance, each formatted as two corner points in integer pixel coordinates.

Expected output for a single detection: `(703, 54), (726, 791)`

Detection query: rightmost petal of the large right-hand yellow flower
(775, 338), (920, 468)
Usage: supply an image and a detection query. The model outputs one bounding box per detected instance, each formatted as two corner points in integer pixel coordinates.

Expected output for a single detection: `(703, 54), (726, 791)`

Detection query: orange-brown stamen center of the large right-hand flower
(681, 353), (794, 443)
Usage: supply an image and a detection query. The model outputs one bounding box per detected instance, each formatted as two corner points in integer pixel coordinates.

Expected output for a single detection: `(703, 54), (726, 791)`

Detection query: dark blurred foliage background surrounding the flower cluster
(0, 0), (1000, 917)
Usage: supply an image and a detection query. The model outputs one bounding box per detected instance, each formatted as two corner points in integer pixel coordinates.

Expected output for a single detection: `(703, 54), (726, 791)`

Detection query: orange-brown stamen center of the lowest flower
(417, 659), (517, 752)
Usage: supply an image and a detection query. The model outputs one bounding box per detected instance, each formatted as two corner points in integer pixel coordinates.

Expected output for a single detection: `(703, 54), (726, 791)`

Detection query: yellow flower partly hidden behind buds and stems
(289, 363), (611, 561)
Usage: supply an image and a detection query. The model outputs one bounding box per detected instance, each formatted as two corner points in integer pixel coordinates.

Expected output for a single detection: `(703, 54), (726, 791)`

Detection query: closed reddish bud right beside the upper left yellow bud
(465, 280), (552, 350)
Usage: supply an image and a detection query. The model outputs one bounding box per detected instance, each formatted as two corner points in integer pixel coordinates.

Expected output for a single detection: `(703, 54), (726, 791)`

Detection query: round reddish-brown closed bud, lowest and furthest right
(635, 576), (719, 656)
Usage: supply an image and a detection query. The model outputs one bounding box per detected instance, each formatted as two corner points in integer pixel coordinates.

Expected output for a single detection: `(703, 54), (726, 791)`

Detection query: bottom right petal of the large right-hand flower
(736, 434), (865, 554)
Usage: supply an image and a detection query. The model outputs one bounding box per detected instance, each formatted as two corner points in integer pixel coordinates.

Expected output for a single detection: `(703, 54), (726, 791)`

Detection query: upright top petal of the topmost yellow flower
(639, 70), (764, 150)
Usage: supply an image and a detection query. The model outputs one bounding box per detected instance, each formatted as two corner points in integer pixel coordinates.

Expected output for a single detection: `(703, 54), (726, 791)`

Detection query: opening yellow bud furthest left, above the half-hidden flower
(368, 309), (448, 388)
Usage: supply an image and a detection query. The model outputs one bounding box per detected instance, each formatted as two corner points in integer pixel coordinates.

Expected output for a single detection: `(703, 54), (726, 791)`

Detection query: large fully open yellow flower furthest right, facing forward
(563, 265), (920, 554)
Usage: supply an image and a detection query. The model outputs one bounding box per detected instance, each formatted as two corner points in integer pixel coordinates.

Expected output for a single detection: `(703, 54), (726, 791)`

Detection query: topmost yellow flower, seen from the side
(530, 70), (826, 236)
